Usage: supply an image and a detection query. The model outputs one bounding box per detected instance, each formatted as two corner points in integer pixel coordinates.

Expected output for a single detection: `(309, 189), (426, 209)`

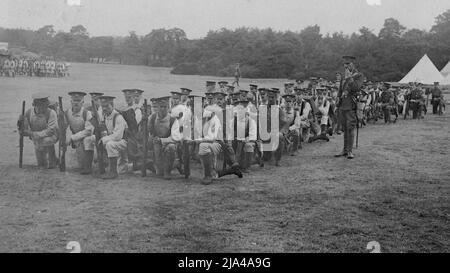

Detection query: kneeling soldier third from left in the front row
(99, 96), (127, 179)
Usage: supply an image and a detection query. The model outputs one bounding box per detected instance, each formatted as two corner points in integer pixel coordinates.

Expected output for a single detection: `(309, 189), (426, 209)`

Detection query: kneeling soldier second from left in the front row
(64, 92), (95, 175)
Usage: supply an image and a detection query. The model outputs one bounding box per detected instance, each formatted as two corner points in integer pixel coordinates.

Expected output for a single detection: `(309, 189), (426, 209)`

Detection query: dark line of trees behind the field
(0, 10), (450, 81)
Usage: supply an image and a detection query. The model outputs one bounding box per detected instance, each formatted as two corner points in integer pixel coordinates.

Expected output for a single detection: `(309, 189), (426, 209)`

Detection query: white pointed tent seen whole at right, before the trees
(399, 54), (444, 84)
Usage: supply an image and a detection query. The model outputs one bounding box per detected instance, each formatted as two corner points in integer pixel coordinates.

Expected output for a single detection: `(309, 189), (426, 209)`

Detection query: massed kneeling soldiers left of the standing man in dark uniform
(19, 78), (344, 184)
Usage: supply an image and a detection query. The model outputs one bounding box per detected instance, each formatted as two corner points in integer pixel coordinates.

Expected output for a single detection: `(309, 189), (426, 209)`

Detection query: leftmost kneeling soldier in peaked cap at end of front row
(21, 93), (58, 169)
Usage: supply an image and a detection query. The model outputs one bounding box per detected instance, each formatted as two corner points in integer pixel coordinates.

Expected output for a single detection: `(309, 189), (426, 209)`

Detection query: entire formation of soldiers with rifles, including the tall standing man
(18, 56), (445, 185)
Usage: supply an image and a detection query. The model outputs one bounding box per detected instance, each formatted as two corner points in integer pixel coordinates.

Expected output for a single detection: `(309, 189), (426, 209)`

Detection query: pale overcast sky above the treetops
(0, 0), (450, 39)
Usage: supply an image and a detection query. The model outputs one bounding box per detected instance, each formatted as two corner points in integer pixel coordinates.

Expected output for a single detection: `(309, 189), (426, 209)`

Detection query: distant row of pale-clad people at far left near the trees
(0, 57), (69, 78)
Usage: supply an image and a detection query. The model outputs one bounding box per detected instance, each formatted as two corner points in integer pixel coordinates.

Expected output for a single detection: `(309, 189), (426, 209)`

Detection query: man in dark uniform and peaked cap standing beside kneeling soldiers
(335, 56), (364, 159)
